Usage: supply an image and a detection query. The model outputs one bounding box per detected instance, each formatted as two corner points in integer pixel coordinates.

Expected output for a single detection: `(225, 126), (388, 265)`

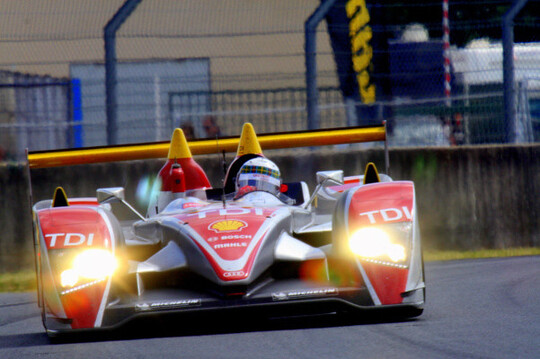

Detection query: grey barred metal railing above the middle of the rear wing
(168, 87), (347, 138)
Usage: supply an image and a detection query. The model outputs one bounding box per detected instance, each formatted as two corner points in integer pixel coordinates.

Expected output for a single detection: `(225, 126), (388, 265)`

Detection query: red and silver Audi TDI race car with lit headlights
(28, 123), (425, 337)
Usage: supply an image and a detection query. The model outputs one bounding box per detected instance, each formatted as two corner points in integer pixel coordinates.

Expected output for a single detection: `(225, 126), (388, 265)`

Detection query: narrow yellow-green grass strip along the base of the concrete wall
(0, 248), (540, 292)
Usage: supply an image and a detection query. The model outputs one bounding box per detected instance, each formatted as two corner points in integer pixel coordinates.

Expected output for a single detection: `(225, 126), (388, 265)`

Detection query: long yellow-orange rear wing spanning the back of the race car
(27, 124), (389, 173)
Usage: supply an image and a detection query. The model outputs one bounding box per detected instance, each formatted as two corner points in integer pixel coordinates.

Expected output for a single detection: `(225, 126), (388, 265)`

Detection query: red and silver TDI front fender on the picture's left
(35, 206), (124, 329)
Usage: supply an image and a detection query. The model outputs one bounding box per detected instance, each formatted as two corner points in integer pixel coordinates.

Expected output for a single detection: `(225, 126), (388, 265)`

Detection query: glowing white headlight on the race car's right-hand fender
(349, 227), (407, 263)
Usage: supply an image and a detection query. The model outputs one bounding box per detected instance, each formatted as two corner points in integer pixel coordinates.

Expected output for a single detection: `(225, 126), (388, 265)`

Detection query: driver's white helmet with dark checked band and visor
(236, 157), (281, 195)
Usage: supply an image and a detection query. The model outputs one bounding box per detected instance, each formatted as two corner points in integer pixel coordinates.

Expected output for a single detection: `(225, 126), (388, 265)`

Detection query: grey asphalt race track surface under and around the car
(0, 256), (540, 359)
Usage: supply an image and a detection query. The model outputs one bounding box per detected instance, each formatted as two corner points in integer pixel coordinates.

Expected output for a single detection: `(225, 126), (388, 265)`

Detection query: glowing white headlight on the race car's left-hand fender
(60, 249), (117, 288)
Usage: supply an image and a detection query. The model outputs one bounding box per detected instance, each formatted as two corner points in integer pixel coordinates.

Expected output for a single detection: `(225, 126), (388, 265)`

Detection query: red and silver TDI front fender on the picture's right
(333, 181), (424, 305)
